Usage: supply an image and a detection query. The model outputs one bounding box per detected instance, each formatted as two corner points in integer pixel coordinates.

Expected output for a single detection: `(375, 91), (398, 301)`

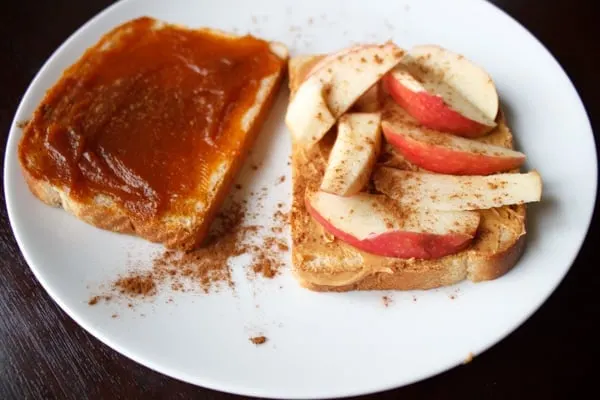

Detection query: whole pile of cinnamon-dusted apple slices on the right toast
(286, 43), (542, 259)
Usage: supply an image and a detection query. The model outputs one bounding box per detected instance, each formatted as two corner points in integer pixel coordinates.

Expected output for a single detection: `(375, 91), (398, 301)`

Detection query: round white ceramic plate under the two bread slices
(5, 0), (597, 398)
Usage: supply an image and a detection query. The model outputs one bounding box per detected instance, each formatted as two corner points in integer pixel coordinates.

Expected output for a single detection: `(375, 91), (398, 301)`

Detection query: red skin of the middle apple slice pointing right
(382, 124), (525, 175)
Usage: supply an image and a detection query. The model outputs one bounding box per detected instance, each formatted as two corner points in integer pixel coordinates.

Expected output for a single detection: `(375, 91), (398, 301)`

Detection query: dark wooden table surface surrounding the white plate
(0, 0), (600, 399)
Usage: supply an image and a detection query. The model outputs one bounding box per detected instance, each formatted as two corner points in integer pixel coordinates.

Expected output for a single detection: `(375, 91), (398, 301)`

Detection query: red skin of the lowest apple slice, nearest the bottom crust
(306, 200), (475, 260)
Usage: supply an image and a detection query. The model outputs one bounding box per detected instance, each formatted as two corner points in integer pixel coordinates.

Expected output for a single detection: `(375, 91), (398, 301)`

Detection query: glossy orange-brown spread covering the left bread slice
(19, 18), (282, 219)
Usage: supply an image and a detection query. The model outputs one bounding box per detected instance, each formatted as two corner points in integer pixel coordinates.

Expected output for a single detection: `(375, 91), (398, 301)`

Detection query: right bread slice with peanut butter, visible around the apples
(289, 55), (526, 291)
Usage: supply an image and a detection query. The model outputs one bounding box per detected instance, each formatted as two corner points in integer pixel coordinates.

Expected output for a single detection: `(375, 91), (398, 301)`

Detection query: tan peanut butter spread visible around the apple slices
(290, 57), (524, 287)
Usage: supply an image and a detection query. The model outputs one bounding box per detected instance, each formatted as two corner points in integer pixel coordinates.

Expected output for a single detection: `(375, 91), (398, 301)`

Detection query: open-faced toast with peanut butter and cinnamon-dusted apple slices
(285, 42), (542, 291)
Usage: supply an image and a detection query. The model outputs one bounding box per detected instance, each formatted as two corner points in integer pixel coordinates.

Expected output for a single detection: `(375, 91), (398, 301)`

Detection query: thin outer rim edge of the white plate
(3, 0), (598, 398)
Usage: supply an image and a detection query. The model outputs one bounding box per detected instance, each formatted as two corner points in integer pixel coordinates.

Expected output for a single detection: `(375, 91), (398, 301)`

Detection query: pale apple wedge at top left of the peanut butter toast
(285, 42), (404, 145)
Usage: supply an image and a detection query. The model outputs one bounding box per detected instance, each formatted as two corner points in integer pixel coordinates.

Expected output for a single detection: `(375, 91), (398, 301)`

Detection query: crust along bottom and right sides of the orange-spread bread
(21, 19), (288, 250)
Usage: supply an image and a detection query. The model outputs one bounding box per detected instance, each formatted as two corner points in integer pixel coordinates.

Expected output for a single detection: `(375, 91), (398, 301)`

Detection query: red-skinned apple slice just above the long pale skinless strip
(381, 106), (525, 175)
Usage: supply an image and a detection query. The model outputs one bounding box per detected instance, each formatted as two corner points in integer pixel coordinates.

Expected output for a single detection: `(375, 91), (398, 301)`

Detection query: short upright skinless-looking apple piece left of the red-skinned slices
(321, 113), (381, 196)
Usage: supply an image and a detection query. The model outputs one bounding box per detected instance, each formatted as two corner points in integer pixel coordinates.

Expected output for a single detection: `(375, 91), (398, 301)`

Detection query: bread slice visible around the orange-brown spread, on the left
(19, 18), (288, 250)
